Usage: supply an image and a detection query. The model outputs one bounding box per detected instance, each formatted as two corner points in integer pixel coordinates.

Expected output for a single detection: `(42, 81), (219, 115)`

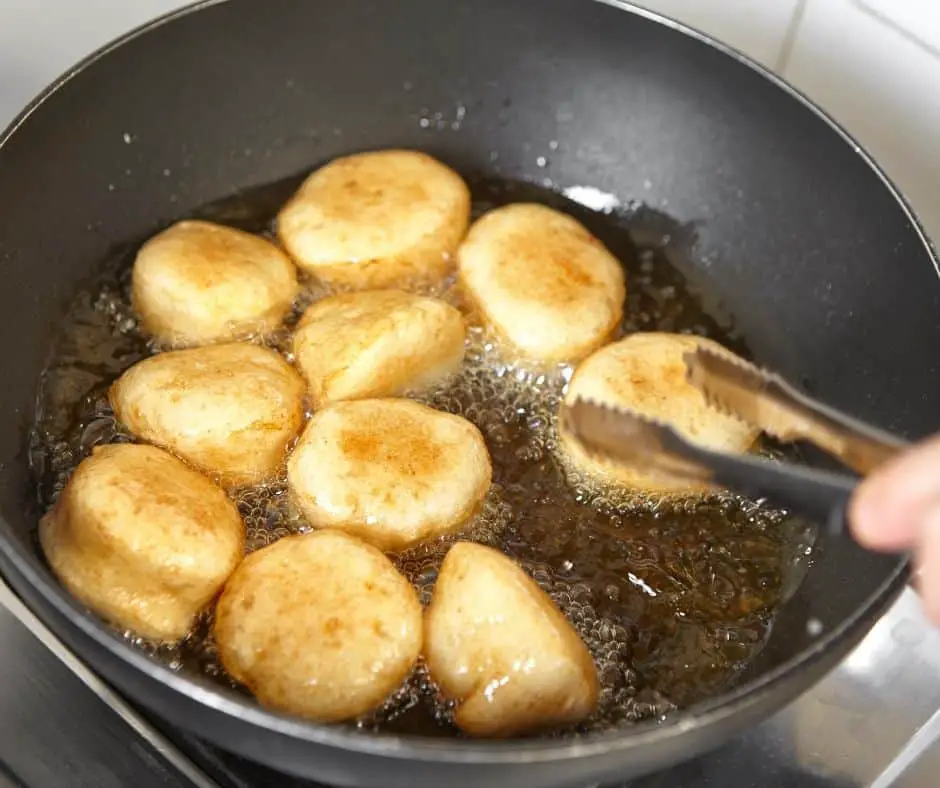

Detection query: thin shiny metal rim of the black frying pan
(0, 0), (928, 765)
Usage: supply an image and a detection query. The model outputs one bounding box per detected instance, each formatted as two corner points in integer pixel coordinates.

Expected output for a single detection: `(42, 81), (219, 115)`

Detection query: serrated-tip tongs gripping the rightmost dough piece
(562, 347), (907, 534)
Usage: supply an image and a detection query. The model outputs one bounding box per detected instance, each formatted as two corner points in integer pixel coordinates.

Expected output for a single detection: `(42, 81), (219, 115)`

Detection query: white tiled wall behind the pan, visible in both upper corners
(0, 0), (940, 240)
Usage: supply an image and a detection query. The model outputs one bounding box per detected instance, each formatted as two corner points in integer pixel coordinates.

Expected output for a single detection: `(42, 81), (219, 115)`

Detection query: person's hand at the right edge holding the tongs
(849, 435), (940, 624)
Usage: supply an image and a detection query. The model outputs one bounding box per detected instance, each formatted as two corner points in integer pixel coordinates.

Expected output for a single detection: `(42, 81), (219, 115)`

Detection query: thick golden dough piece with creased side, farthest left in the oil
(39, 444), (245, 641)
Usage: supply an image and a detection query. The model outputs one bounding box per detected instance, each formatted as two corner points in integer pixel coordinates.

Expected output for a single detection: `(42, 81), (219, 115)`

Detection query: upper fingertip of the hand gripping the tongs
(849, 436), (940, 552)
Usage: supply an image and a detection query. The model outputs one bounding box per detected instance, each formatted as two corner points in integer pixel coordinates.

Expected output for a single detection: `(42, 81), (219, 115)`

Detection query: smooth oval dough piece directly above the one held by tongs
(457, 203), (626, 362)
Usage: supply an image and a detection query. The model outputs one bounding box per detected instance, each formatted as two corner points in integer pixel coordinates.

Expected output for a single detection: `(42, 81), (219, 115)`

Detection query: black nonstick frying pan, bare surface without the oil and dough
(0, 0), (940, 788)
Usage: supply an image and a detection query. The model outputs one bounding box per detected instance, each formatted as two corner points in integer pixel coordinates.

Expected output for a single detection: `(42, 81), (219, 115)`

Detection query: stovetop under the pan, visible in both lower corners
(0, 582), (940, 788)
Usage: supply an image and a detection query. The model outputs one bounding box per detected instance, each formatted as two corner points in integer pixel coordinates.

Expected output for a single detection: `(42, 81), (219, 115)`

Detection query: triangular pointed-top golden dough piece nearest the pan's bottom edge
(424, 542), (598, 737)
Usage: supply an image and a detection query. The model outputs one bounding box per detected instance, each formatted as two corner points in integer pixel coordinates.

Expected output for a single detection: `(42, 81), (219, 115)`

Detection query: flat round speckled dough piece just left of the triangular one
(214, 531), (422, 722)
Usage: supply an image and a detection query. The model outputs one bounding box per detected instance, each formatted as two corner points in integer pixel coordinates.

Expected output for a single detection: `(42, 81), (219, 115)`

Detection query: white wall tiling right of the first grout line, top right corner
(783, 0), (940, 241)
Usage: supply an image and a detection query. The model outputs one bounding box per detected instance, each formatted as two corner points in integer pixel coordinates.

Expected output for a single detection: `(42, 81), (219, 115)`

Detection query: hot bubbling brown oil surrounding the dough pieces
(30, 169), (814, 735)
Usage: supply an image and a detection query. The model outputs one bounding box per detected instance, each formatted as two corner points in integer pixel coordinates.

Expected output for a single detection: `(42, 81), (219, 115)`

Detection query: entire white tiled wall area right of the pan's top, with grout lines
(638, 0), (940, 241)
